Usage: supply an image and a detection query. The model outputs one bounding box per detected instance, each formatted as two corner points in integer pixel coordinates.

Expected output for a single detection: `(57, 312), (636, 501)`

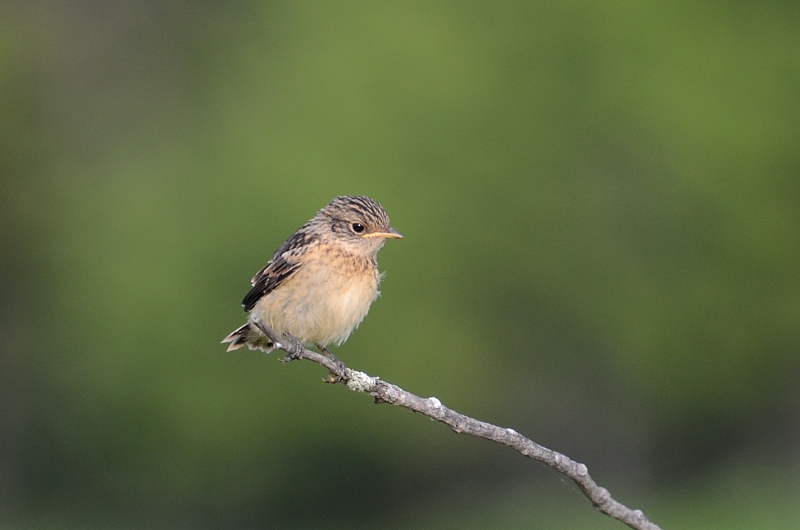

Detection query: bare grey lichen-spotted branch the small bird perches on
(251, 315), (660, 530)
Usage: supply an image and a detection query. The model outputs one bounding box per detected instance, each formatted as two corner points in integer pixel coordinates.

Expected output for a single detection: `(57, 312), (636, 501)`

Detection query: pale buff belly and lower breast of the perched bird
(254, 260), (379, 346)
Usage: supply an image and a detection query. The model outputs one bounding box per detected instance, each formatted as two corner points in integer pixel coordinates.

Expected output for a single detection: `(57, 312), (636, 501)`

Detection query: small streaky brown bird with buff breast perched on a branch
(222, 196), (403, 355)
